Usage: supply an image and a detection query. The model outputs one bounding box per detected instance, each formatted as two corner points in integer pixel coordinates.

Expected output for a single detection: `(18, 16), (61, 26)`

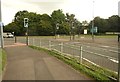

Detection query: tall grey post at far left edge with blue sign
(0, 0), (4, 48)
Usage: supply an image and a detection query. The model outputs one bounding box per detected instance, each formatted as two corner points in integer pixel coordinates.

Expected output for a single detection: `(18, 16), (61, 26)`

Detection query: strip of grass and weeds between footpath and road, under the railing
(29, 46), (117, 82)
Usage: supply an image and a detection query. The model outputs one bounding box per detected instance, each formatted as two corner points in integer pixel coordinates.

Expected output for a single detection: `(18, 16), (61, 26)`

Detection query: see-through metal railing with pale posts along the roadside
(17, 38), (118, 73)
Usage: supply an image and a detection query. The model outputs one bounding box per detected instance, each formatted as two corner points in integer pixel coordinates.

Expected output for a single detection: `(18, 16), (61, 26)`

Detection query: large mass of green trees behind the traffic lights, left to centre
(4, 9), (82, 35)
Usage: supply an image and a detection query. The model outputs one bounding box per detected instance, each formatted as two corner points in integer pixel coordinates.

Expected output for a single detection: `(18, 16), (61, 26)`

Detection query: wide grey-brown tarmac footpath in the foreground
(3, 43), (93, 80)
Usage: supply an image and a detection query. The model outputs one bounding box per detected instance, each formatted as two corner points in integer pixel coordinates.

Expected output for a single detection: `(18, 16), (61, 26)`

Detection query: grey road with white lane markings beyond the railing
(3, 37), (118, 72)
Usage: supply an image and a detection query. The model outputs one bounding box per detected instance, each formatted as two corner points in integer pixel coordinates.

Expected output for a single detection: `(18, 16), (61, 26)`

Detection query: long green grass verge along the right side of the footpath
(30, 46), (115, 82)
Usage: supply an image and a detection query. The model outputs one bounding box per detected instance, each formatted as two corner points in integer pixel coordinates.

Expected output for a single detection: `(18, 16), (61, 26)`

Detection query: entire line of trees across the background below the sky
(4, 9), (120, 35)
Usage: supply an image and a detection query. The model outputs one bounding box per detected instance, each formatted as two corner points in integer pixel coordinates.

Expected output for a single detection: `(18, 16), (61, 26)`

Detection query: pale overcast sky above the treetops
(1, 0), (120, 25)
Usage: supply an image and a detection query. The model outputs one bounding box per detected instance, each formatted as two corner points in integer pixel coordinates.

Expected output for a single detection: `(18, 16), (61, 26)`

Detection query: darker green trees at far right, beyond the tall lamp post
(89, 15), (120, 34)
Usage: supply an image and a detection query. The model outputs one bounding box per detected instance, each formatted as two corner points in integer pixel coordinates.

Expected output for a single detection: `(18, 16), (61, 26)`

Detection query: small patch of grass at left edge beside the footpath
(0, 49), (7, 73)
